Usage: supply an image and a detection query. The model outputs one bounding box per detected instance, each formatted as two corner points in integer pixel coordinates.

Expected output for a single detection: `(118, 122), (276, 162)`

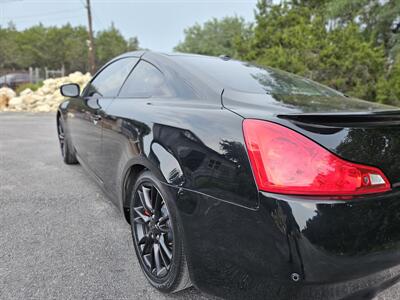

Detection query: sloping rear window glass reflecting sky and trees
(175, 55), (343, 97)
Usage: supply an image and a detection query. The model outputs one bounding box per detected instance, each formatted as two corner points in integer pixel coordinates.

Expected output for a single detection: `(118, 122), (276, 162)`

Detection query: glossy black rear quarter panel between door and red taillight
(103, 98), (258, 207)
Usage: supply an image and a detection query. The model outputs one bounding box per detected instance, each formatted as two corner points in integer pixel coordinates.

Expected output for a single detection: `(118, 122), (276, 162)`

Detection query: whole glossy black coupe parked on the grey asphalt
(57, 51), (400, 299)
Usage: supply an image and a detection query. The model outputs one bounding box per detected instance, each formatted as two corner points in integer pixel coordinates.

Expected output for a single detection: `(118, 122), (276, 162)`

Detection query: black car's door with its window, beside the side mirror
(70, 57), (139, 181)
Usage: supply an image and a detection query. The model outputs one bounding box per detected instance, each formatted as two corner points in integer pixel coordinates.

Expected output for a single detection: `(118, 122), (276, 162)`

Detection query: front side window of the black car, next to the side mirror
(84, 57), (139, 97)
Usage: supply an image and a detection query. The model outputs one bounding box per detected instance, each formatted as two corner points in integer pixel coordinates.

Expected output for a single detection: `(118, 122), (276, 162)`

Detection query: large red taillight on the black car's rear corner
(243, 119), (390, 196)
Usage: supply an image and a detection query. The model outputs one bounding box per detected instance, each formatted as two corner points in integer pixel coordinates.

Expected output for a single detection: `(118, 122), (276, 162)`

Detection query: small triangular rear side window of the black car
(119, 60), (172, 98)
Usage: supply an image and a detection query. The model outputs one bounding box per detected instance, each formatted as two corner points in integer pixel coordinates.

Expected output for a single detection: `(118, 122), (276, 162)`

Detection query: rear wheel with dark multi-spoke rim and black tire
(130, 171), (191, 293)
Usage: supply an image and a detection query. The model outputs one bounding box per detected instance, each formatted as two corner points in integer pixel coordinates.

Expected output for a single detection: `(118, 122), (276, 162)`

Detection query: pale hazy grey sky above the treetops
(0, 0), (257, 52)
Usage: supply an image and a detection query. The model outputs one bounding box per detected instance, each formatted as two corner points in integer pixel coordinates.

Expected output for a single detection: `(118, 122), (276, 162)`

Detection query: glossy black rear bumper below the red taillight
(171, 188), (400, 299)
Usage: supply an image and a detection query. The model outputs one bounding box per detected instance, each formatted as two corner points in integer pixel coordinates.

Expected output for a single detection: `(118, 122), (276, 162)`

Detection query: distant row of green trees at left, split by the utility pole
(0, 24), (139, 72)
